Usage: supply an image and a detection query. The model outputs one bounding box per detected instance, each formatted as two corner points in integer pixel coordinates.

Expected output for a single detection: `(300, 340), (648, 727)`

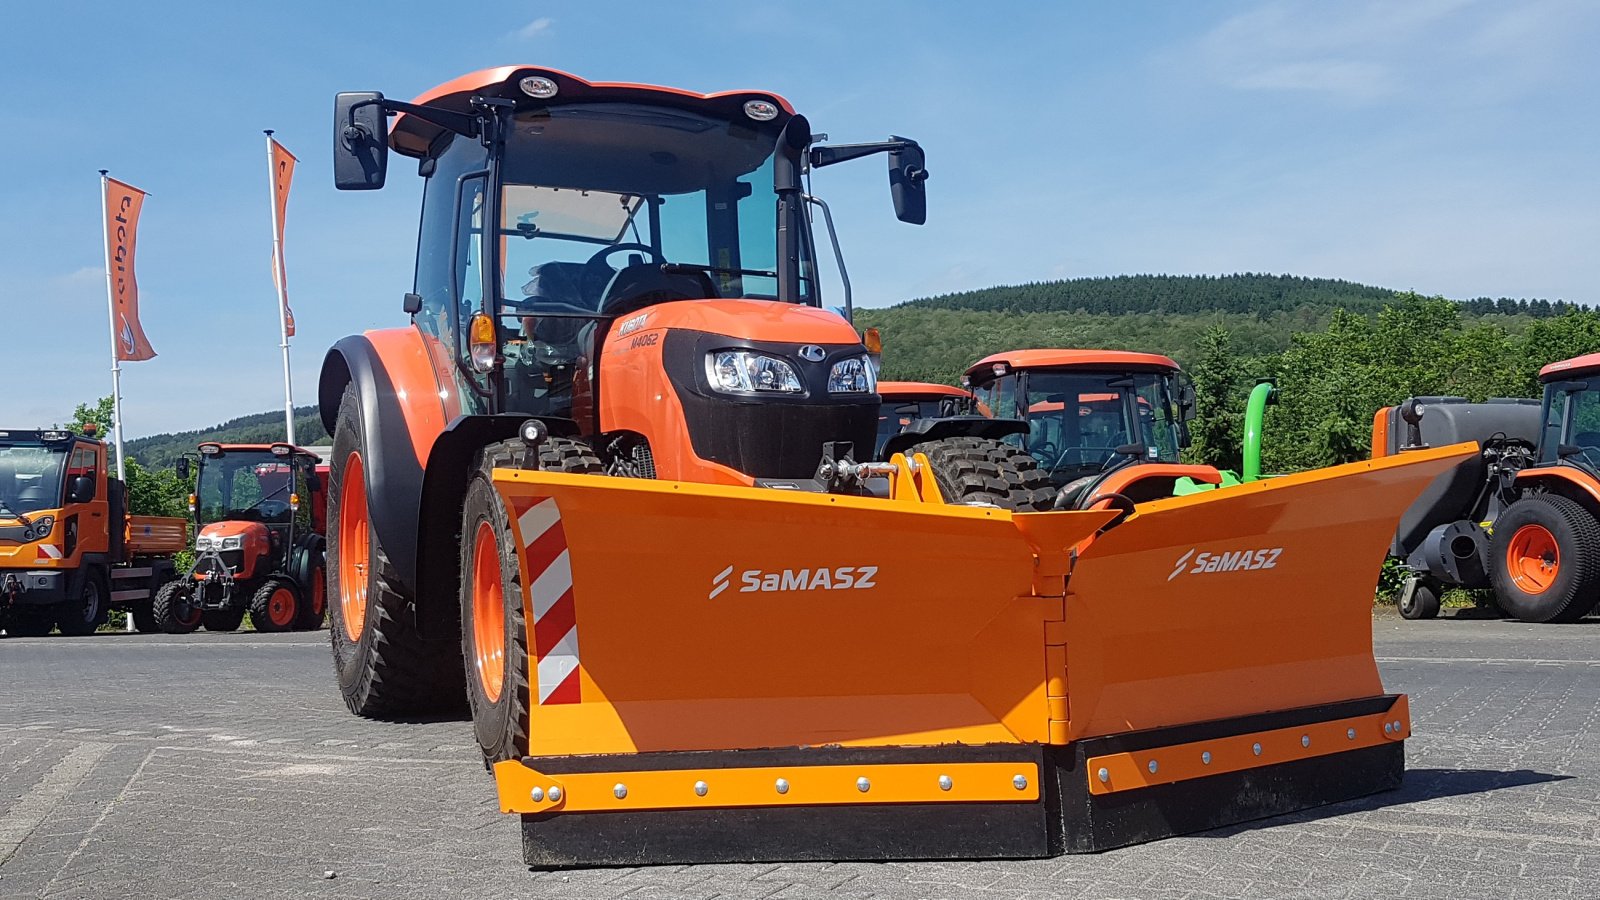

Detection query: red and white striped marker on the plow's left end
(514, 496), (582, 706)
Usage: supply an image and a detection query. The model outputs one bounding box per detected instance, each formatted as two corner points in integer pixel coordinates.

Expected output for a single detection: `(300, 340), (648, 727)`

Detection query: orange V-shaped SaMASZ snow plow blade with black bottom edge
(494, 445), (1475, 866)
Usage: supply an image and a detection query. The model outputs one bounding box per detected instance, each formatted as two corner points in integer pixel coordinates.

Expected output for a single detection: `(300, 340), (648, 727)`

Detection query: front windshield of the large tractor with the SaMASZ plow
(499, 102), (813, 317)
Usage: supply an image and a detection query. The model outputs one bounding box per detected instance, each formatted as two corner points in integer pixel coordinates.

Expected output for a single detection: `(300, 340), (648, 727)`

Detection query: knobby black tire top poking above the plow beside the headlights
(915, 437), (1056, 512)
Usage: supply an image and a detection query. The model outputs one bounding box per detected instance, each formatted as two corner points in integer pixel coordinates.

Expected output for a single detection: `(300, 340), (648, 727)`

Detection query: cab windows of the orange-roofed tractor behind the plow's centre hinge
(978, 370), (1179, 484)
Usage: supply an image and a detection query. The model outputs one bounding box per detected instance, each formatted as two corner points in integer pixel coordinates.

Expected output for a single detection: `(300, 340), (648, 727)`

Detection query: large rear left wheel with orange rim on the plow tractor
(326, 377), (466, 719)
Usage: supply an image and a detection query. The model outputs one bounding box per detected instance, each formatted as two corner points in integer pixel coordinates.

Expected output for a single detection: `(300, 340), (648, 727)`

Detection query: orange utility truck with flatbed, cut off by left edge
(0, 429), (187, 637)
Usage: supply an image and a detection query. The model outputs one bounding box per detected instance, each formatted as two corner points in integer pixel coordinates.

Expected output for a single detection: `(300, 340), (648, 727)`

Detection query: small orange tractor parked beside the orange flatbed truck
(155, 444), (328, 634)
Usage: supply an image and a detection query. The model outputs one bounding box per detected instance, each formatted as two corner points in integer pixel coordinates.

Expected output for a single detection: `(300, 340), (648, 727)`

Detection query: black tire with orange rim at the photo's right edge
(1490, 493), (1600, 621)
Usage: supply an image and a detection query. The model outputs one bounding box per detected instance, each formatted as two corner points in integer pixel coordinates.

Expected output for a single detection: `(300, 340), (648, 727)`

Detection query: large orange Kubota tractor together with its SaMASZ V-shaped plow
(318, 67), (1470, 866)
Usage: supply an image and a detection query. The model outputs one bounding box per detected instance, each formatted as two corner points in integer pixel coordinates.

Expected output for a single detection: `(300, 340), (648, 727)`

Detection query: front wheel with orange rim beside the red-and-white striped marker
(461, 437), (605, 765)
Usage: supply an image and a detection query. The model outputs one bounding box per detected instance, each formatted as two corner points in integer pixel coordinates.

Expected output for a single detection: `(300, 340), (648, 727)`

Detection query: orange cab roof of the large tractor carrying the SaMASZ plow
(389, 66), (795, 157)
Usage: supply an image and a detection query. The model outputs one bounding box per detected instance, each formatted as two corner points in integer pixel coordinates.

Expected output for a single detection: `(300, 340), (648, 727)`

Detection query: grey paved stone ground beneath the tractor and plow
(0, 617), (1600, 900)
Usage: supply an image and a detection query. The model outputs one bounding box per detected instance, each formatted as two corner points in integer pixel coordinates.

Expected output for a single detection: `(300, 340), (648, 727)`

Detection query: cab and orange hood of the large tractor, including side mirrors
(334, 66), (925, 484)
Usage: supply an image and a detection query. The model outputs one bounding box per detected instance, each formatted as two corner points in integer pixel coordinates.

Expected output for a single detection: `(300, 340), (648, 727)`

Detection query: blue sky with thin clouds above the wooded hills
(0, 0), (1600, 437)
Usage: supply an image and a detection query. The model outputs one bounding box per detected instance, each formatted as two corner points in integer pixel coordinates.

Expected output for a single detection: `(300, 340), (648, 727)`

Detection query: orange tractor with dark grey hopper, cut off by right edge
(1373, 354), (1600, 621)
